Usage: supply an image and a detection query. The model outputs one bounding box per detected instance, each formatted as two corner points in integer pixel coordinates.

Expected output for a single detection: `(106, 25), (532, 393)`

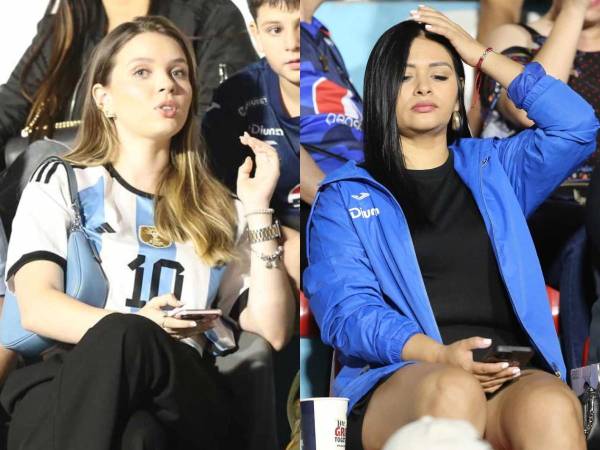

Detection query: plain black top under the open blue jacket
(407, 152), (530, 359)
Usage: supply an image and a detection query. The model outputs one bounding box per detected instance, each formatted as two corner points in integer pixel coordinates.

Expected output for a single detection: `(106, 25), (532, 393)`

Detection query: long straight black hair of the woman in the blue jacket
(363, 20), (471, 221)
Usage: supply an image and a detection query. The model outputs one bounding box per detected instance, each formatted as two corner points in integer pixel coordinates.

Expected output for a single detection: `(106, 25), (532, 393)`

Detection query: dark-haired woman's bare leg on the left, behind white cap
(362, 363), (486, 450)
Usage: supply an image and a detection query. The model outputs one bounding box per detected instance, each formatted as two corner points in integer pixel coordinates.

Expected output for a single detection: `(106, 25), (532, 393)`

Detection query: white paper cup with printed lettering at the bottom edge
(300, 397), (348, 450)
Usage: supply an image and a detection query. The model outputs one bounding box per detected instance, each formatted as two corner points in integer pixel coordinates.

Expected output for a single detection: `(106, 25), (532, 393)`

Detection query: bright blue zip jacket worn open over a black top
(304, 63), (599, 408)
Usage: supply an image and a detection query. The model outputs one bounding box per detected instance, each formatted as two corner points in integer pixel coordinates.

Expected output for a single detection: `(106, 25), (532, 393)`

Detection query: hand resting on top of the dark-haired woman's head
(411, 5), (485, 67)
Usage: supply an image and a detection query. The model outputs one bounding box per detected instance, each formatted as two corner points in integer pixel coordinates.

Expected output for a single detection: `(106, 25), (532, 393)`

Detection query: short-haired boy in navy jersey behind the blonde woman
(202, 0), (300, 288)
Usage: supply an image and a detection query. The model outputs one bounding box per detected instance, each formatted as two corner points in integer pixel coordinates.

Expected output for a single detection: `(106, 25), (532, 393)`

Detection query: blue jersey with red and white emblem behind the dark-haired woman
(300, 17), (363, 173)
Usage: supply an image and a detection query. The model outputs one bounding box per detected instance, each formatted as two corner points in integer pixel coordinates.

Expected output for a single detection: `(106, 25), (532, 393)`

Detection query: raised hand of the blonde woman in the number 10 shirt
(237, 133), (279, 211)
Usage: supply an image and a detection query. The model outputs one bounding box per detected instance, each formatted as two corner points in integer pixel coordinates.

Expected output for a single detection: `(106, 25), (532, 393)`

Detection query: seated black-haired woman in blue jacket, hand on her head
(304, 6), (599, 450)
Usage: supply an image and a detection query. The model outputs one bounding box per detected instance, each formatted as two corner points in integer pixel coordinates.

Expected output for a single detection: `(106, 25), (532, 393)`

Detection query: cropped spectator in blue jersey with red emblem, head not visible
(300, 0), (364, 304)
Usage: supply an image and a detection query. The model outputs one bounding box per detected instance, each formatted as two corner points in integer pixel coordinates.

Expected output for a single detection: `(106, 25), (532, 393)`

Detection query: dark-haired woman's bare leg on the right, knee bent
(485, 370), (586, 450)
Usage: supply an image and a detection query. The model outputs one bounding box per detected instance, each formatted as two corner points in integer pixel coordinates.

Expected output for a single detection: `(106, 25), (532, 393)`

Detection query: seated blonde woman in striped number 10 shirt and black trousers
(0, 17), (294, 450)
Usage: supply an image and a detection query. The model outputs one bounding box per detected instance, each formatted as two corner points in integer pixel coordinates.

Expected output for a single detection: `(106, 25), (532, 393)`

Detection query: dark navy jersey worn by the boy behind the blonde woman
(202, 58), (300, 230)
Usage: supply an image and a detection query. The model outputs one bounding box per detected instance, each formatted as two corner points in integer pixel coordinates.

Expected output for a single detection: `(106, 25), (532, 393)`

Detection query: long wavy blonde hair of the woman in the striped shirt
(65, 16), (236, 265)
